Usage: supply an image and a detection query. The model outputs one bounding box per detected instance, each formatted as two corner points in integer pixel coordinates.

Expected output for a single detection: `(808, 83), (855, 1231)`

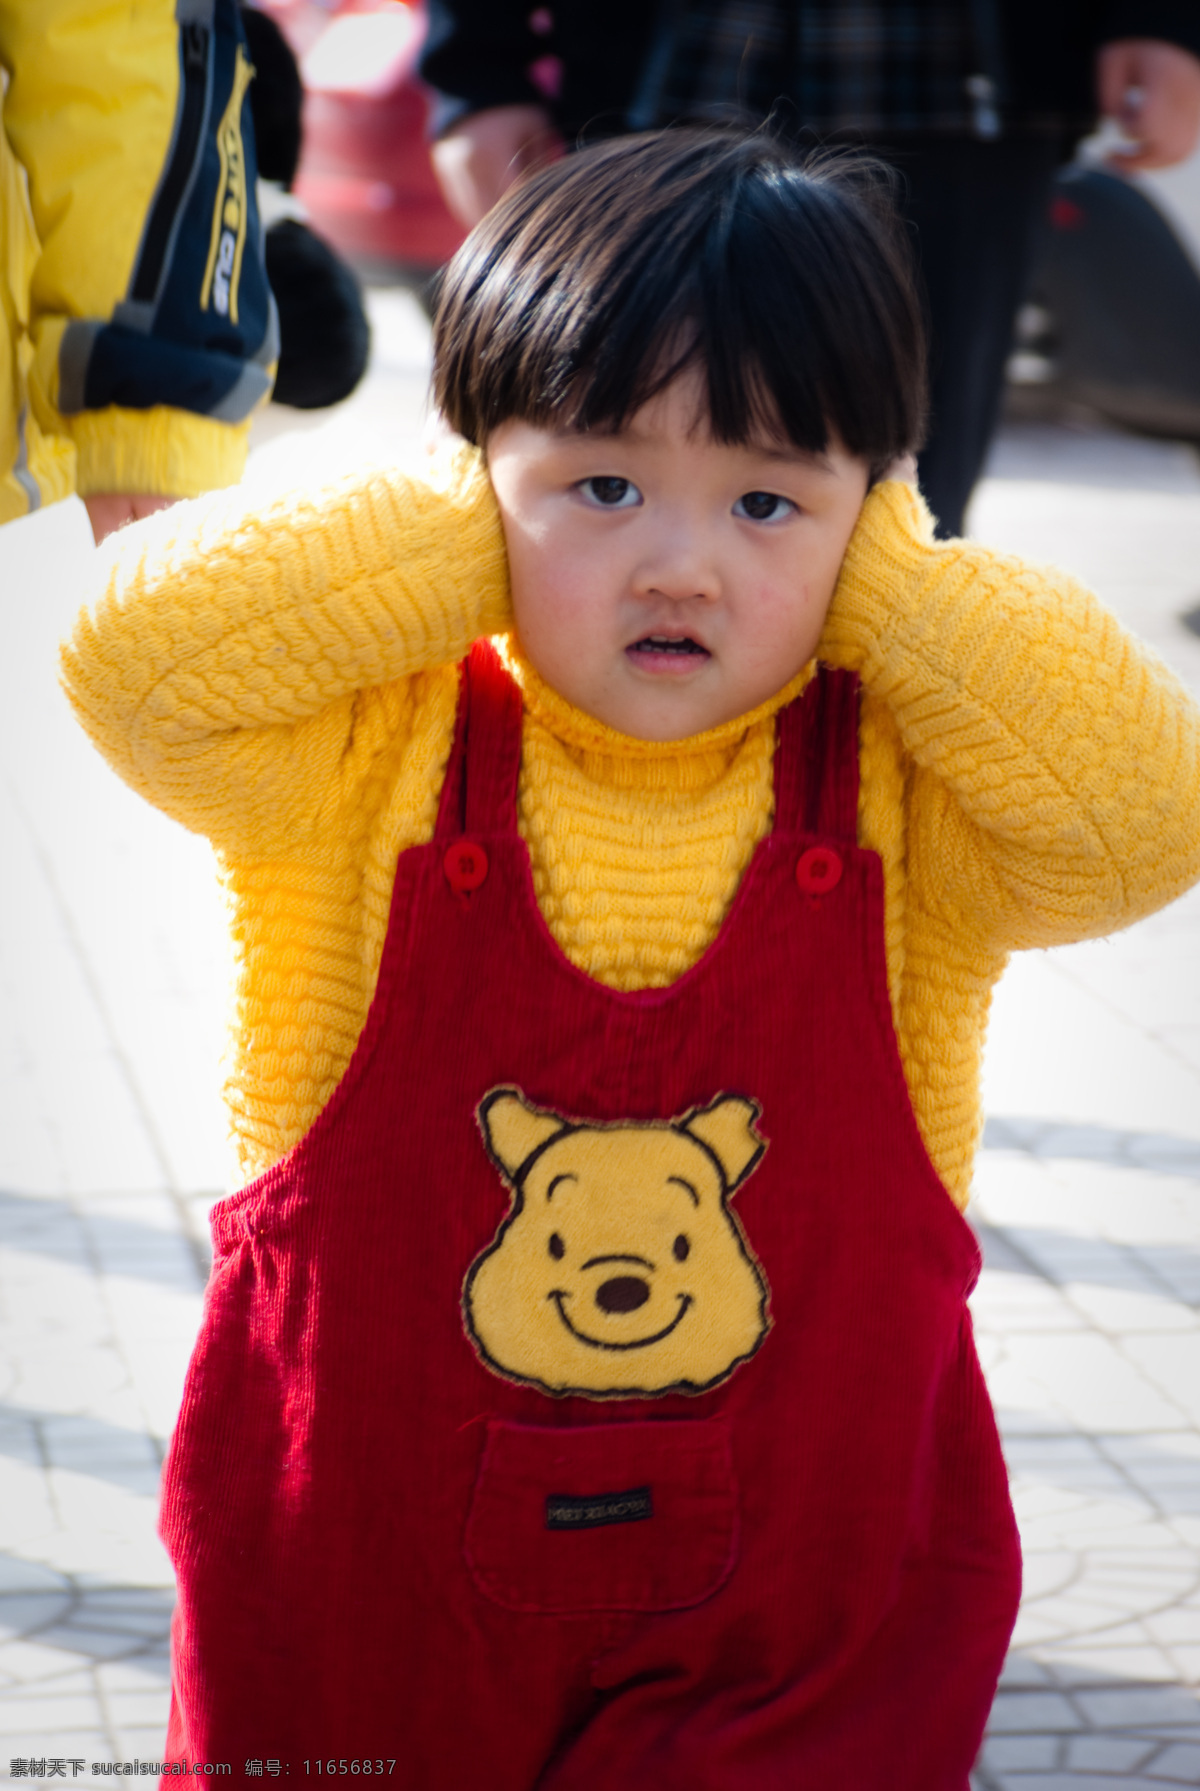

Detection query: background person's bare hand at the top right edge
(1096, 38), (1200, 172)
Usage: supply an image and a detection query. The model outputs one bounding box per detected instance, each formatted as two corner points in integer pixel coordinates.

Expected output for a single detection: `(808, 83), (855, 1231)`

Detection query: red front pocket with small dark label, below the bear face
(464, 1418), (738, 1615)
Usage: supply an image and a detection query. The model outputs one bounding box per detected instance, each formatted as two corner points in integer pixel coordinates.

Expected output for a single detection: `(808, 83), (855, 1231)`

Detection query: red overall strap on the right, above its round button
(776, 664), (858, 845)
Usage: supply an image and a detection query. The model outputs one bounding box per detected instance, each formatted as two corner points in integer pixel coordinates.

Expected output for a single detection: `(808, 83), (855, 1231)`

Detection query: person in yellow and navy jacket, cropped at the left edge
(0, 0), (278, 541)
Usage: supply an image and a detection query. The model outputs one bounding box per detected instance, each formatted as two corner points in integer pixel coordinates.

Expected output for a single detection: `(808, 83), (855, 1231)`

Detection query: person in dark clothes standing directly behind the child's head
(421, 0), (1200, 536)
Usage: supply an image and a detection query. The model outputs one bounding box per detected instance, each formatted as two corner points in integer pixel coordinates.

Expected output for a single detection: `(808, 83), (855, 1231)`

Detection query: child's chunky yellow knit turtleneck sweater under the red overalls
(64, 455), (1200, 1204)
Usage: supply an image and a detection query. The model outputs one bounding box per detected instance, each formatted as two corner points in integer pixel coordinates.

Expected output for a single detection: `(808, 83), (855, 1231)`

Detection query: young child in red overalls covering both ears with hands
(66, 131), (1200, 1791)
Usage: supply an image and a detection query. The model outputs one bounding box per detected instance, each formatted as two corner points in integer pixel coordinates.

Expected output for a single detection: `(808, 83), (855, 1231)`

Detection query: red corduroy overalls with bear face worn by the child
(163, 648), (1019, 1791)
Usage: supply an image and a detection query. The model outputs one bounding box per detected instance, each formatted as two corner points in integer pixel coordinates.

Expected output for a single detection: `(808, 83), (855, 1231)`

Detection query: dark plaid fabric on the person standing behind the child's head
(630, 0), (1002, 138)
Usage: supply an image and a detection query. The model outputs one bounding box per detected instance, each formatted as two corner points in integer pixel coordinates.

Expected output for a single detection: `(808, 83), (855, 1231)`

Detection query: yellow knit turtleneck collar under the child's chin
(496, 636), (815, 790)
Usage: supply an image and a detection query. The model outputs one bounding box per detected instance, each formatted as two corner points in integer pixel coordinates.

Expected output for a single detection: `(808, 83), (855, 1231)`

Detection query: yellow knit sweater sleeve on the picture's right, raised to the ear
(820, 484), (1200, 951)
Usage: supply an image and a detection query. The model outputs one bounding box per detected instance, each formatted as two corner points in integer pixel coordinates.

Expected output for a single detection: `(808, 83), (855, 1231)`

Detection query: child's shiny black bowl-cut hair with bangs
(433, 127), (926, 478)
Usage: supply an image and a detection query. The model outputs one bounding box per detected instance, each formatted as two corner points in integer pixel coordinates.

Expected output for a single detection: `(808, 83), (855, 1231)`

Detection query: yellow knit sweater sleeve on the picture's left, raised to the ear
(63, 451), (509, 858)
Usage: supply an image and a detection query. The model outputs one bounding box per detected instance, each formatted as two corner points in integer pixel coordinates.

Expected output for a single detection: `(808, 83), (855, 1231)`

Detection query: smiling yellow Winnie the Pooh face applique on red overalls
(462, 1087), (770, 1399)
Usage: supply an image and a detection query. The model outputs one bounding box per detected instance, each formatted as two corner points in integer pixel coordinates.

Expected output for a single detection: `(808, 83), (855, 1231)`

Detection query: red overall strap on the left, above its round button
(433, 641), (521, 840)
